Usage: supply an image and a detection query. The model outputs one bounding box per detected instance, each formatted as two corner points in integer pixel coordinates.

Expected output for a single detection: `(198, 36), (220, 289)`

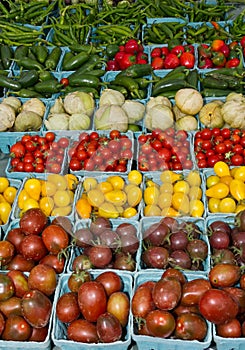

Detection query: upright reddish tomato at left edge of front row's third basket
(131, 286), (156, 319)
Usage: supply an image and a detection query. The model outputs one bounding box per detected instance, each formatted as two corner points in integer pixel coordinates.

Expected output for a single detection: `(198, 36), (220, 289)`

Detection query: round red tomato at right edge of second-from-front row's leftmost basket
(42, 224), (69, 254)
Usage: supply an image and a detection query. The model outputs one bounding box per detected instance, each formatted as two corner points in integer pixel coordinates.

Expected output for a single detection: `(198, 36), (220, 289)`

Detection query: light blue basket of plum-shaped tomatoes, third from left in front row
(131, 271), (212, 350)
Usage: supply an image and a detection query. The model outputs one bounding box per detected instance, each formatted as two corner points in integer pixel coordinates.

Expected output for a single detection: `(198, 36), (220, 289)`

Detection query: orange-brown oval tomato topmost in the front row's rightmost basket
(209, 264), (241, 288)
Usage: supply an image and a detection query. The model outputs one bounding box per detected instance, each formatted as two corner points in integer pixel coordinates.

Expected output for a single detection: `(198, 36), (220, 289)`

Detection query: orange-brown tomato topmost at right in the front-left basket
(28, 264), (57, 296)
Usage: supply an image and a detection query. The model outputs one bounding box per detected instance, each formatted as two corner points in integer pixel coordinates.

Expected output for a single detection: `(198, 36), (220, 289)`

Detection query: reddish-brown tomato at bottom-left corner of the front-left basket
(2, 315), (32, 341)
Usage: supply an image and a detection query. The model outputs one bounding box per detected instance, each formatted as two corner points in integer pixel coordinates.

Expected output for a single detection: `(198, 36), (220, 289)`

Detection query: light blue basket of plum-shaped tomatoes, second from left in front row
(51, 270), (132, 350)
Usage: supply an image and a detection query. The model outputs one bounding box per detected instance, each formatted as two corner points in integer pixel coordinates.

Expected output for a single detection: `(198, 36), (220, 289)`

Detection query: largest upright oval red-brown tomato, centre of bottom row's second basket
(78, 281), (107, 322)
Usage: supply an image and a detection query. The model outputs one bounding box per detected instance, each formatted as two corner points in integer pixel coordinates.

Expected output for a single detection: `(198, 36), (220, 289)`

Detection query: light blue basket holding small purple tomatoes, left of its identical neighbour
(67, 219), (141, 275)
